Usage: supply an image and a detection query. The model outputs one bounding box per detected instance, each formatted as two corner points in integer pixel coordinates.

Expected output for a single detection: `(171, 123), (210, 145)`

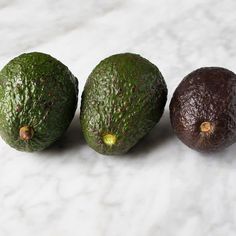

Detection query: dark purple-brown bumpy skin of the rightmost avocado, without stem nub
(170, 67), (236, 152)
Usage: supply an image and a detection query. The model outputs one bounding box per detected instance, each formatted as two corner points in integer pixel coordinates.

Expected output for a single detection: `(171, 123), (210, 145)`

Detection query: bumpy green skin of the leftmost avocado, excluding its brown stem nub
(0, 52), (78, 152)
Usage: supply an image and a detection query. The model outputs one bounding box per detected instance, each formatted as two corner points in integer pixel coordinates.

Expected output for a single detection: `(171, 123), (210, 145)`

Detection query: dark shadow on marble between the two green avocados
(42, 114), (86, 154)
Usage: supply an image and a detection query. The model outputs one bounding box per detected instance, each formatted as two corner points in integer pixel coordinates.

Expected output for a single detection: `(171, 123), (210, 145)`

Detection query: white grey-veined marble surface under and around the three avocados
(0, 0), (236, 236)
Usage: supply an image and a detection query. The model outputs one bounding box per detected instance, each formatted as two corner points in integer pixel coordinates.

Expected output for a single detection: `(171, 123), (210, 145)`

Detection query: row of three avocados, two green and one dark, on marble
(0, 52), (236, 155)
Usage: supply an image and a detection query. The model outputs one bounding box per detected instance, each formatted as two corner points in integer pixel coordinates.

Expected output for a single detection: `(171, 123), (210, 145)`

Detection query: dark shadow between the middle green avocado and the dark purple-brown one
(127, 111), (174, 157)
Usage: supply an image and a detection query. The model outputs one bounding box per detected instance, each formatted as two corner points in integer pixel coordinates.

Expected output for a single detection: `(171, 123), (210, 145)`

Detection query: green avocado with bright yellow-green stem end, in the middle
(80, 53), (167, 155)
